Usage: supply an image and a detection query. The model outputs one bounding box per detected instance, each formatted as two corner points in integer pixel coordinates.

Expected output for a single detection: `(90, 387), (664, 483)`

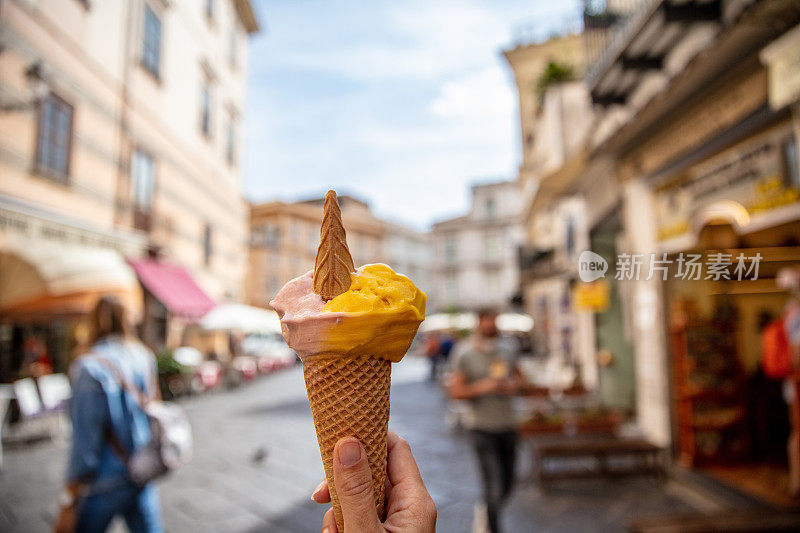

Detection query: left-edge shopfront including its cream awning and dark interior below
(0, 241), (141, 382)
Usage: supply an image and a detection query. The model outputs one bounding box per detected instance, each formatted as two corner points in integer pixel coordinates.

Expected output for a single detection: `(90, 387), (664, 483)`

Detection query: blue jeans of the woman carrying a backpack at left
(75, 483), (164, 533)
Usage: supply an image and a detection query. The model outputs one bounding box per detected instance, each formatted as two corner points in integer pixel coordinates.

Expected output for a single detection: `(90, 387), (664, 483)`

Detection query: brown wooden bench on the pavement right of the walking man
(532, 437), (665, 486)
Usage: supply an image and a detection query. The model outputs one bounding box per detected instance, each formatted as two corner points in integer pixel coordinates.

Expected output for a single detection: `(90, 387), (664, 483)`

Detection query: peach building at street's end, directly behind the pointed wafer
(247, 195), (430, 307)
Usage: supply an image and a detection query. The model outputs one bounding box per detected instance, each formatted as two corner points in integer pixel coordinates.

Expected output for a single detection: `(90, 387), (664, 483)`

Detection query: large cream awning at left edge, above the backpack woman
(0, 239), (140, 316)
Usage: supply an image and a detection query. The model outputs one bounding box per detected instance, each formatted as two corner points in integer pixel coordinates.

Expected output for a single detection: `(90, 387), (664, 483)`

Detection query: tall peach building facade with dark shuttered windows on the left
(0, 0), (258, 370)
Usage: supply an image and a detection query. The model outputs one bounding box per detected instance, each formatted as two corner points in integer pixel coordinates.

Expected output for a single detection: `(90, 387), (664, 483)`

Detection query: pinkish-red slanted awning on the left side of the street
(129, 259), (217, 320)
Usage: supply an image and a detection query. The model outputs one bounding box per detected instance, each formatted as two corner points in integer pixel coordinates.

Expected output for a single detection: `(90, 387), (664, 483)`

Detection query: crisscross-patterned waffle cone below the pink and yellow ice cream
(303, 356), (392, 532)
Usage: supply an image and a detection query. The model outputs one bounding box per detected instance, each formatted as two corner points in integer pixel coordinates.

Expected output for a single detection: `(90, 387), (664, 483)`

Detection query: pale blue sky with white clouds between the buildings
(244, 0), (580, 230)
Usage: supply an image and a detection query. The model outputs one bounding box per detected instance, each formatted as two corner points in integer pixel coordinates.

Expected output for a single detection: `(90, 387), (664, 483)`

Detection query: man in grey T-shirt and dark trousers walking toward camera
(448, 309), (524, 533)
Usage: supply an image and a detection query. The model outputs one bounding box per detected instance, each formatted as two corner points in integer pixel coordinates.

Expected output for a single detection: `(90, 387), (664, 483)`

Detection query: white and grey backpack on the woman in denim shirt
(98, 357), (194, 486)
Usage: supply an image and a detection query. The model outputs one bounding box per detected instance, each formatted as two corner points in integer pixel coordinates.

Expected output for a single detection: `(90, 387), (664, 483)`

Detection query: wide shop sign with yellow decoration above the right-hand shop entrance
(656, 128), (800, 241)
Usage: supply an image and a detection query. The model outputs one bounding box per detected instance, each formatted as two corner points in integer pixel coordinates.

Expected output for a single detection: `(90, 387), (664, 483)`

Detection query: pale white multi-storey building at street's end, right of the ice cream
(431, 181), (522, 312)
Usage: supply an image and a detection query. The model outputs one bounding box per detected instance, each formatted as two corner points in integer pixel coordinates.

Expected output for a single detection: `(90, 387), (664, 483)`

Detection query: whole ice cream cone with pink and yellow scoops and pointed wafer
(271, 191), (426, 532)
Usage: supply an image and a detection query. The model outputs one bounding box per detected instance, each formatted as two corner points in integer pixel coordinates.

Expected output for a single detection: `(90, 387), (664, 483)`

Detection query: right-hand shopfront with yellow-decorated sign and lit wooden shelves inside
(655, 114), (800, 505)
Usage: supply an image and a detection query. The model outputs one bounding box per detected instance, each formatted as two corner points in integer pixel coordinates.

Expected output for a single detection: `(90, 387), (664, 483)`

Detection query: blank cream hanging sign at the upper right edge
(760, 26), (800, 110)
